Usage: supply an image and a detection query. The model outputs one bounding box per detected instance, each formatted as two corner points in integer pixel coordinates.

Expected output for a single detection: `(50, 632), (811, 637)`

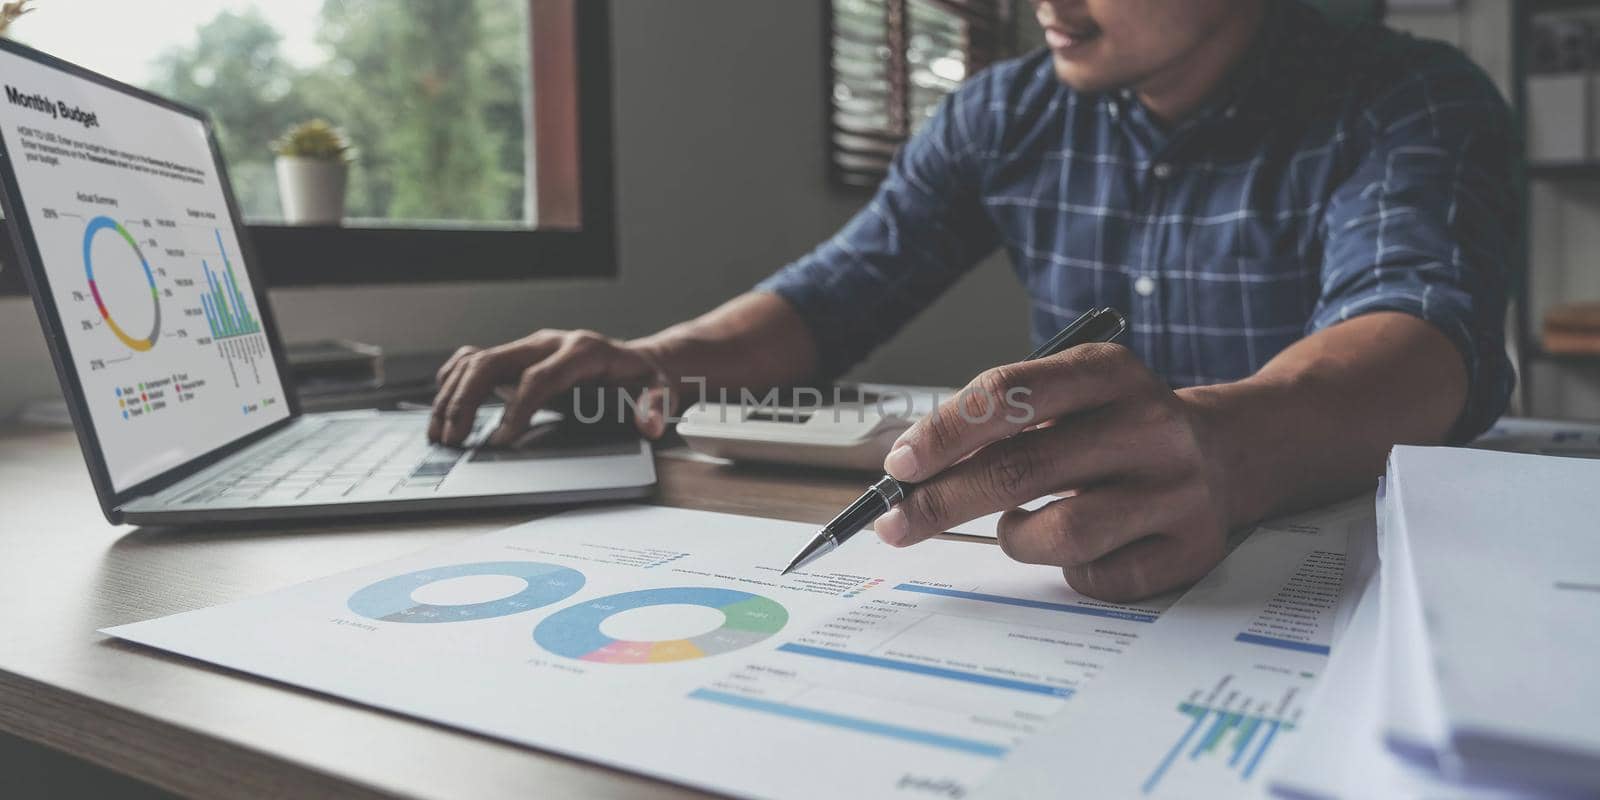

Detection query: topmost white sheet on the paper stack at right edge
(1389, 446), (1600, 792)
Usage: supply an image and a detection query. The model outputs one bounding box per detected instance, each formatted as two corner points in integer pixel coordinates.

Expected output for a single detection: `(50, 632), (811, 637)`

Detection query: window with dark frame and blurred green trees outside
(3, 0), (614, 285)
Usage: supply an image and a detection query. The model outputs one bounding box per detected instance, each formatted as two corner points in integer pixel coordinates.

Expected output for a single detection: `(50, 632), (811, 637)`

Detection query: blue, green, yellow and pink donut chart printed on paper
(533, 587), (789, 664)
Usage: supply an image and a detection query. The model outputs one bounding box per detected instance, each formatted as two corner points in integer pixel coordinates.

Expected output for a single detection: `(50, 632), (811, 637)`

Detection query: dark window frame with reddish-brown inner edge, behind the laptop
(0, 0), (618, 296)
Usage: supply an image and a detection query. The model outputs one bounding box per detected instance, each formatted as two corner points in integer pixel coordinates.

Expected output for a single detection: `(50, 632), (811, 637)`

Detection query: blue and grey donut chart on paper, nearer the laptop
(349, 562), (584, 622)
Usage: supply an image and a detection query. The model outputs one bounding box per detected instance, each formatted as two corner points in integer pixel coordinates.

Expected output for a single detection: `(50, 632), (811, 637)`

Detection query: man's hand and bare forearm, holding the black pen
(877, 312), (1467, 600)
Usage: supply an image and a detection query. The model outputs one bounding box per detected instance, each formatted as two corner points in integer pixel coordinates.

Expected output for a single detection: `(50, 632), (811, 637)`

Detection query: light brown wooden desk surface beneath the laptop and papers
(0, 429), (953, 798)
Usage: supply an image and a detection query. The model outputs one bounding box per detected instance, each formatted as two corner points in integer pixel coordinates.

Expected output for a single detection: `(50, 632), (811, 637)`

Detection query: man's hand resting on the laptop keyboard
(427, 330), (670, 445)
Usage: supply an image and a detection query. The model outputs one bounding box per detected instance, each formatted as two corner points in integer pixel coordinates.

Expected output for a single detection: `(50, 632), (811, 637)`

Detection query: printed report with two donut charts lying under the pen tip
(106, 506), (1168, 798)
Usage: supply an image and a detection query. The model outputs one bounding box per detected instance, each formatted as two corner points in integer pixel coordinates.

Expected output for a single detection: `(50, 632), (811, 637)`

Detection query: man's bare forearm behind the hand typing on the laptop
(629, 293), (818, 402)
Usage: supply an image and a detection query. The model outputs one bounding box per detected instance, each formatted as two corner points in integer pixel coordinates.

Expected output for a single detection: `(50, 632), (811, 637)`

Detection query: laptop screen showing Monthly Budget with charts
(0, 51), (290, 491)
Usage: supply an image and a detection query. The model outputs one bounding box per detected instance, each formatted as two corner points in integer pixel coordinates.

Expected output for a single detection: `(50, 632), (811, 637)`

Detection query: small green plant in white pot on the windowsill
(272, 120), (355, 226)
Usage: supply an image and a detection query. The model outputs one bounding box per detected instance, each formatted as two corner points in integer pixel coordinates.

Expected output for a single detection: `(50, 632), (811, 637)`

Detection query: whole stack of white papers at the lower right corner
(1269, 446), (1600, 797)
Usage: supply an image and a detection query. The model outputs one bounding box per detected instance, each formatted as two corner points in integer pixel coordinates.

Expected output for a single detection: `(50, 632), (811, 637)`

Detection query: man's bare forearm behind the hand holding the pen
(1179, 312), (1467, 526)
